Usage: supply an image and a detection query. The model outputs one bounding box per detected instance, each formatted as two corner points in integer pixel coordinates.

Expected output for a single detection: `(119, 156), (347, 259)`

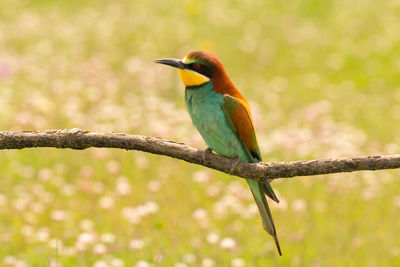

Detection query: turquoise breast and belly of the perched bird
(185, 82), (249, 162)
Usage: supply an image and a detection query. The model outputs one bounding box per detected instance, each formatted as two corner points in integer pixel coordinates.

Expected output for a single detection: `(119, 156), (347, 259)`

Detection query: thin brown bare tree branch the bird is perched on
(0, 129), (400, 181)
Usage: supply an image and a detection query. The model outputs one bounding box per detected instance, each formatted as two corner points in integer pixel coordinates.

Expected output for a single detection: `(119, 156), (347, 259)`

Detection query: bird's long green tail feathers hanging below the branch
(246, 179), (282, 256)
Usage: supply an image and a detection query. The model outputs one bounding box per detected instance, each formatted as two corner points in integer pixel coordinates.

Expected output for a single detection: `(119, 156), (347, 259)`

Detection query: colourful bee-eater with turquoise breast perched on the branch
(154, 51), (282, 255)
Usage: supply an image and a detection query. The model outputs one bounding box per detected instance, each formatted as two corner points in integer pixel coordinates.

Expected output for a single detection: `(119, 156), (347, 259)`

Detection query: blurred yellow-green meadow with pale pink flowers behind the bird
(0, 0), (400, 267)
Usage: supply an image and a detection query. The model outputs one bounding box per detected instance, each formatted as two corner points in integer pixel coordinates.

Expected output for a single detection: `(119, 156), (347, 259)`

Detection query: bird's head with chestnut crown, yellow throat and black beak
(155, 51), (225, 87)
